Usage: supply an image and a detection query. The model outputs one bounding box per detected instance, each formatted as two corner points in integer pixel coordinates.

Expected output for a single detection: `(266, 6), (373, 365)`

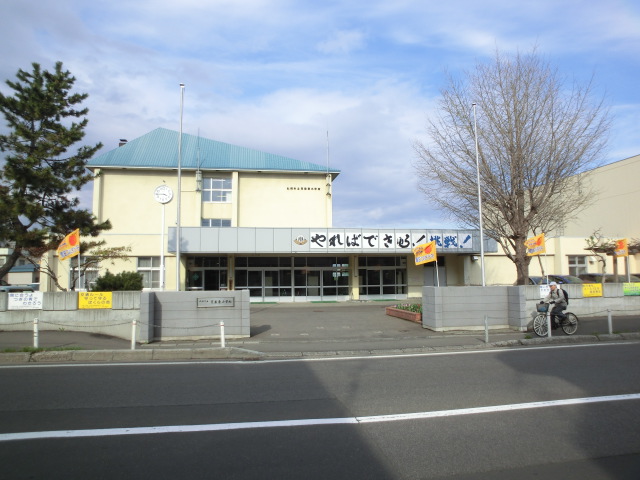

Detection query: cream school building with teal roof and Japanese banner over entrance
(23, 128), (640, 302)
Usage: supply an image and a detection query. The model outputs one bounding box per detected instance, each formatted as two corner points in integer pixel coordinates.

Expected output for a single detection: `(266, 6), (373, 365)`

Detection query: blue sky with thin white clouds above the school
(0, 0), (640, 228)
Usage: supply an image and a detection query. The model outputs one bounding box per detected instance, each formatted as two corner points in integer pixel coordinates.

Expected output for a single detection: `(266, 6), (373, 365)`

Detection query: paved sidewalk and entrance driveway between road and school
(0, 301), (640, 364)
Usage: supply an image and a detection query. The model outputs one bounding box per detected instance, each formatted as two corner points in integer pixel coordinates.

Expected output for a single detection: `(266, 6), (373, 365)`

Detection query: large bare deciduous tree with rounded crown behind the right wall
(414, 48), (610, 285)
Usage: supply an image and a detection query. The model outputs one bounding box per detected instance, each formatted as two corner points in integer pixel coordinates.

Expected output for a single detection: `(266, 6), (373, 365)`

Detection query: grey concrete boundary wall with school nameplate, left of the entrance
(0, 290), (251, 343)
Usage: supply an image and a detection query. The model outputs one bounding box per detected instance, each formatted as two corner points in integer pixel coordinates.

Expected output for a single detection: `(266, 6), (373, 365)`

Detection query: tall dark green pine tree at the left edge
(0, 62), (111, 278)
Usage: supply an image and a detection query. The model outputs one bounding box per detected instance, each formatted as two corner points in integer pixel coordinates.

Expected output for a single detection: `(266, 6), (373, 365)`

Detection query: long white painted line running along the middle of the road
(0, 393), (640, 442)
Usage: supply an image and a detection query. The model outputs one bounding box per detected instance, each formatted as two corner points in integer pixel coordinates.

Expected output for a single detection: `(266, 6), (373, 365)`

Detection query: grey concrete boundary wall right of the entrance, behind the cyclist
(422, 284), (640, 331)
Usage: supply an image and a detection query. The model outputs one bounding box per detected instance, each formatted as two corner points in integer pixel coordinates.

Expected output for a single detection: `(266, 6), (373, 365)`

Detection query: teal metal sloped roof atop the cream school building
(87, 128), (340, 176)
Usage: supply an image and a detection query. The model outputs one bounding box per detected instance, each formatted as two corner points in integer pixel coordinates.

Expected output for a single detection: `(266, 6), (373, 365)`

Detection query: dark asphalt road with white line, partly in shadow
(0, 342), (640, 480)
